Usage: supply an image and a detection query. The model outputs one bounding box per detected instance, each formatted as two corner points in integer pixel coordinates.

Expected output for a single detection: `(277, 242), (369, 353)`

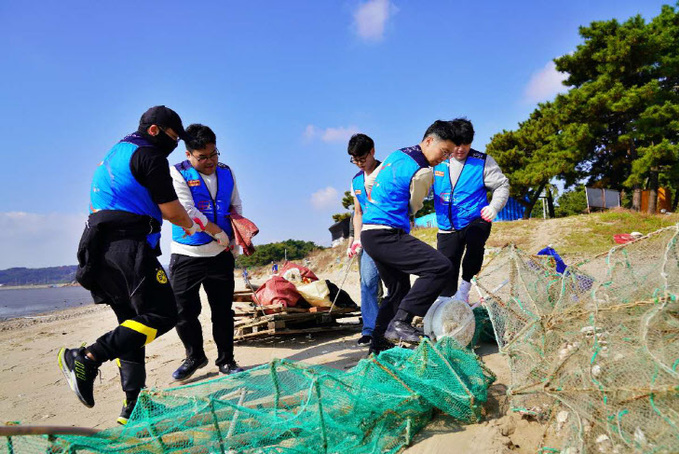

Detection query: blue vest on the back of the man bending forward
(363, 145), (429, 233)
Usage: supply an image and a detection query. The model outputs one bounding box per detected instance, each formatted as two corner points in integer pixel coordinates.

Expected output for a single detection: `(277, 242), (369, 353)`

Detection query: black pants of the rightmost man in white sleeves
(436, 218), (493, 296)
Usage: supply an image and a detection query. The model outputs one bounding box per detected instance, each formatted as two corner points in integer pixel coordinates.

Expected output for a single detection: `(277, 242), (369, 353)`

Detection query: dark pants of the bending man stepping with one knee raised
(361, 229), (451, 337)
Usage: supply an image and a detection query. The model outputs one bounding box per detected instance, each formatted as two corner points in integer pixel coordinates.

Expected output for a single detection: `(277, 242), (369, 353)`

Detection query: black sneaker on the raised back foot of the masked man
(57, 347), (99, 408)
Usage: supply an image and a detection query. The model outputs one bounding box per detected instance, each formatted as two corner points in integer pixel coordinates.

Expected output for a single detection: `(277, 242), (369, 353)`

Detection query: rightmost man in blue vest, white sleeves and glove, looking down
(434, 118), (509, 302)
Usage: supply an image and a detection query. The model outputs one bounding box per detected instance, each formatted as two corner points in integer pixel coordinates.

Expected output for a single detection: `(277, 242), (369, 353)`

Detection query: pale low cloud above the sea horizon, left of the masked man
(0, 211), (87, 269)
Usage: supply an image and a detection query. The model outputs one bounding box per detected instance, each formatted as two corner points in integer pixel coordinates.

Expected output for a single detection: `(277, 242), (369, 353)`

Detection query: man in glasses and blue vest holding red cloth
(170, 124), (243, 380)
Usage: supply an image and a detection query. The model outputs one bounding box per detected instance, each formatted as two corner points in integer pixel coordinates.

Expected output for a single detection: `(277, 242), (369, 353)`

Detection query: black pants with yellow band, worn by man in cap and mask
(87, 239), (177, 391)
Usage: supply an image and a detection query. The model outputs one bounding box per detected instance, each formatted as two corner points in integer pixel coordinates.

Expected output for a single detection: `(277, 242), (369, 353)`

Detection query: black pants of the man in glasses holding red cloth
(170, 251), (235, 366)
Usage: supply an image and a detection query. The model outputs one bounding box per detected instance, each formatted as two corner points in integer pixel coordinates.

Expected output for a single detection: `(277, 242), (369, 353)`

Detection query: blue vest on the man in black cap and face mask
(90, 133), (163, 248)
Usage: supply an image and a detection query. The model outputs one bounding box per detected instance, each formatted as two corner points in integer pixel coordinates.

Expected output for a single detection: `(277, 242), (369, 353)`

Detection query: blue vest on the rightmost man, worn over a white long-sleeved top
(434, 150), (488, 230)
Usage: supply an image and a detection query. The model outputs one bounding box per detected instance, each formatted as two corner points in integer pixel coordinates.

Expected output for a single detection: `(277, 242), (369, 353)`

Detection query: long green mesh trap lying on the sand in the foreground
(0, 339), (495, 454)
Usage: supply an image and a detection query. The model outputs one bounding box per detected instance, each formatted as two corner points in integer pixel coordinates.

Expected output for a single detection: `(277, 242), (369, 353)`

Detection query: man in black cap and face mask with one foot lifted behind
(58, 106), (200, 424)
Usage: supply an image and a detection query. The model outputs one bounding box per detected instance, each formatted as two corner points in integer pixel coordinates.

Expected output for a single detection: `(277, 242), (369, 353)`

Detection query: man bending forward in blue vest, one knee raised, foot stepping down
(361, 120), (455, 353)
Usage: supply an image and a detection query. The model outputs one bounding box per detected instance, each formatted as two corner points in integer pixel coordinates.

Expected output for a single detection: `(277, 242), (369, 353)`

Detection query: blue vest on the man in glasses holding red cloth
(172, 160), (234, 246)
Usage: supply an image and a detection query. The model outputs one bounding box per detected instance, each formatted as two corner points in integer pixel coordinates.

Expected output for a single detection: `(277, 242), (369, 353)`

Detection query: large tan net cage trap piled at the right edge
(476, 224), (679, 454)
